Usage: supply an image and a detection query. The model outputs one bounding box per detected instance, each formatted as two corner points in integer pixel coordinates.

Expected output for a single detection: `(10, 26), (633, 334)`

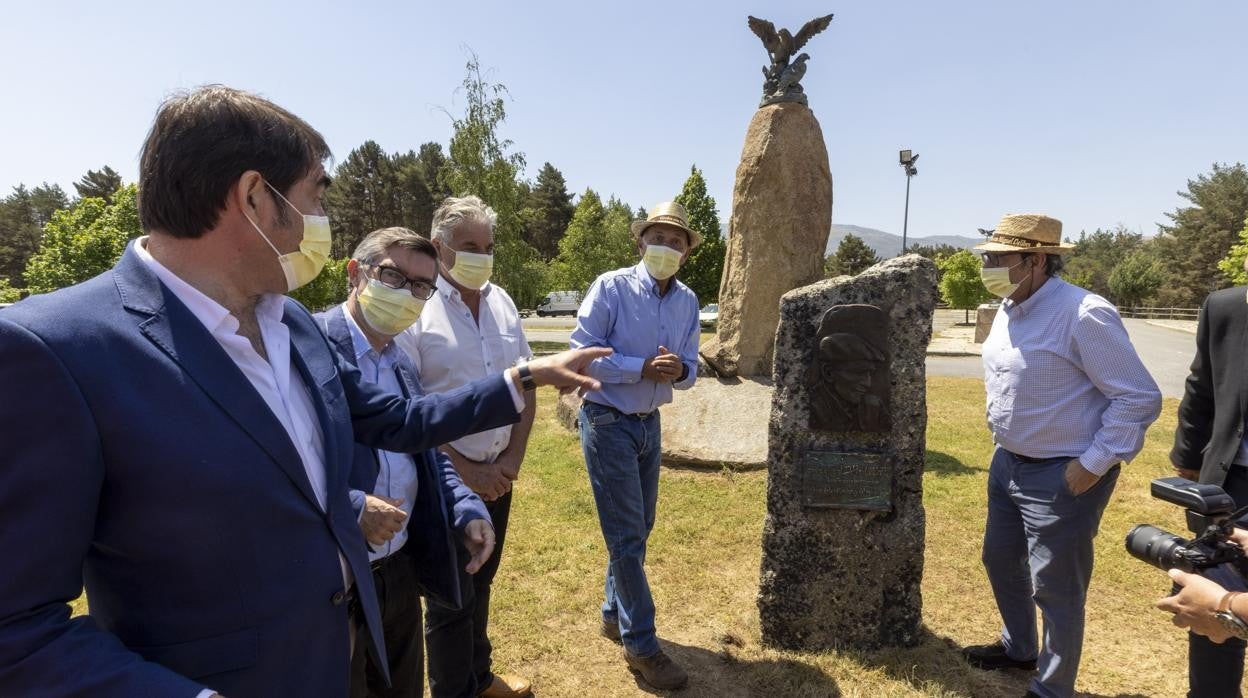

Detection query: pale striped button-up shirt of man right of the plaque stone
(983, 277), (1162, 474)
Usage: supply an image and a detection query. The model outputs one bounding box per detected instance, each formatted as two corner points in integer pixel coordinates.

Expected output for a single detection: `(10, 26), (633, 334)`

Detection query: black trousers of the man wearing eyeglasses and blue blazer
(351, 552), (424, 698)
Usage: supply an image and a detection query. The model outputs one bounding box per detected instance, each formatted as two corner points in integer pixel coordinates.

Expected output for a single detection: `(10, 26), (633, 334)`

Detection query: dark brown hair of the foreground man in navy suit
(139, 85), (329, 237)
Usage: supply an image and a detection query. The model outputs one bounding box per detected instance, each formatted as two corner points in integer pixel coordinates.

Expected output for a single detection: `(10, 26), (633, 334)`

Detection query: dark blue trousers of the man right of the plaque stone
(983, 448), (1119, 698)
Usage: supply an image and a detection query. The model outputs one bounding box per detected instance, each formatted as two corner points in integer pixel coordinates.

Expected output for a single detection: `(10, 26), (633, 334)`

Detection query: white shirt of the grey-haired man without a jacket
(394, 275), (533, 463)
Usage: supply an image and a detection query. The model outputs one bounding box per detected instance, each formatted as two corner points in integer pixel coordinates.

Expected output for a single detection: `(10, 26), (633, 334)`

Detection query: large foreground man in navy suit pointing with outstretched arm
(0, 86), (598, 698)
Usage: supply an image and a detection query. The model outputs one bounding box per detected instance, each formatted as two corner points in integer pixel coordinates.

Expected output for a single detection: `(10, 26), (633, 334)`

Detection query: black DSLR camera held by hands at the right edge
(1127, 477), (1248, 589)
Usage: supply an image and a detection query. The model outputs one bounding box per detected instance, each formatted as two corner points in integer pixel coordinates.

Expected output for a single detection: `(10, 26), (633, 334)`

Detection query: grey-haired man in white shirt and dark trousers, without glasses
(397, 196), (537, 698)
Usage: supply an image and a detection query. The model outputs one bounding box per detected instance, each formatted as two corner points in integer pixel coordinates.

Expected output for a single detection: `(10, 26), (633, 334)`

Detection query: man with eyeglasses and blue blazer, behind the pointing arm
(317, 227), (494, 698)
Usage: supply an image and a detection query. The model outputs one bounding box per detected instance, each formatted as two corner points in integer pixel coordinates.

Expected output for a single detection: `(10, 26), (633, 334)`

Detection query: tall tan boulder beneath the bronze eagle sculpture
(701, 104), (832, 377)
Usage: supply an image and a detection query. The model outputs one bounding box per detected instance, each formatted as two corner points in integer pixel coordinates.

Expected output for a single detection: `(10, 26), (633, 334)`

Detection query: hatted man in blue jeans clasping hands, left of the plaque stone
(572, 202), (701, 689)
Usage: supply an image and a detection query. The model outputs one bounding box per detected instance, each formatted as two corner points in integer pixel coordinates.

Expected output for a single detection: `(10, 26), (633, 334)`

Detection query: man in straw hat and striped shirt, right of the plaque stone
(963, 214), (1162, 698)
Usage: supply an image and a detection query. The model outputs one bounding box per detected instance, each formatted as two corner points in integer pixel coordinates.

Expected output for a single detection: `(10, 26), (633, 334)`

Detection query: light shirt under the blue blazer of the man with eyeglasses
(342, 303), (419, 562)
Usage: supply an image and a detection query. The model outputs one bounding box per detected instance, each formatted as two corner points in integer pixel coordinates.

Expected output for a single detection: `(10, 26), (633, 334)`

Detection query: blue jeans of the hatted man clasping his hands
(579, 401), (660, 657)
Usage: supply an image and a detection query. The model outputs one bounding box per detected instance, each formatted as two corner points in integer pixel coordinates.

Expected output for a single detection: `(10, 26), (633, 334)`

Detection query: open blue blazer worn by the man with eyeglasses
(316, 306), (489, 608)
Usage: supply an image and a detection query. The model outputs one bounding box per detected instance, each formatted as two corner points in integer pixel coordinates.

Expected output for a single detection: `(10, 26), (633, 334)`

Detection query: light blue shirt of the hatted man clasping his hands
(570, 263), (700, 413)
